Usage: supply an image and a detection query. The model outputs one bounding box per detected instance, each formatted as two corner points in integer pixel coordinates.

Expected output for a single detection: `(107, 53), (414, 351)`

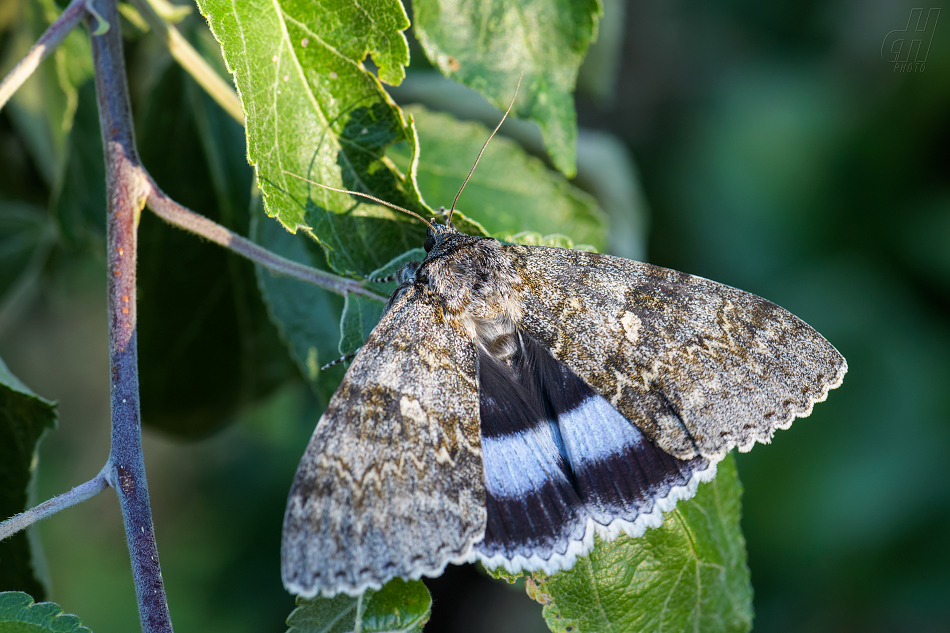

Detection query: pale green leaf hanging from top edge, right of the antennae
(412, 0), (603, 176)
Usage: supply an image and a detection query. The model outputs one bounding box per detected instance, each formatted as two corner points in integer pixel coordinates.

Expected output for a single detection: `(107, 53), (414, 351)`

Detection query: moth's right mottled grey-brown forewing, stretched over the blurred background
(506, 246), (847, 461)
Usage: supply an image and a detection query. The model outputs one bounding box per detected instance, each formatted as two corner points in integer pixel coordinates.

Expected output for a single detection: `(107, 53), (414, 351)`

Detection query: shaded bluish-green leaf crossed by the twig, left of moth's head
(251, 195), (343, 397)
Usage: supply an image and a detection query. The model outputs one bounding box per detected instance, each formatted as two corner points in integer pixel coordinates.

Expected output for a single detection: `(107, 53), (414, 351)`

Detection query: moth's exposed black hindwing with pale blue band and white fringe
(476, 332), (716, 574)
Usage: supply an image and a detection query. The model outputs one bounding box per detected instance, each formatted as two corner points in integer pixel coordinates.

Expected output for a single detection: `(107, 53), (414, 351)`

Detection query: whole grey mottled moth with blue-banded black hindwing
(281, 92), (847, 597)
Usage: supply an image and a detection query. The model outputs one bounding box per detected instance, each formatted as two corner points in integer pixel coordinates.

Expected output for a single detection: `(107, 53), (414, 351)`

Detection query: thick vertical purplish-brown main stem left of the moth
(90, 0), (172, 633)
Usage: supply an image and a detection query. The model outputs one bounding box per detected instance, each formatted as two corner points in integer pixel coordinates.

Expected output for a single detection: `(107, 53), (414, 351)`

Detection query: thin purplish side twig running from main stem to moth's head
(147, 183), (386, 302)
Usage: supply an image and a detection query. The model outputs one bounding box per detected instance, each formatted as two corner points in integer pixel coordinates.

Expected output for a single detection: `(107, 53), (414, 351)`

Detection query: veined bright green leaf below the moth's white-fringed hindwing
(528, 455), (752, 633)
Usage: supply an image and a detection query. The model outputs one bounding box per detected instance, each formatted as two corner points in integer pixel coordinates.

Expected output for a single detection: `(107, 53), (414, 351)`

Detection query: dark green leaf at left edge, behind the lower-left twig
(0, 360), (56, 597)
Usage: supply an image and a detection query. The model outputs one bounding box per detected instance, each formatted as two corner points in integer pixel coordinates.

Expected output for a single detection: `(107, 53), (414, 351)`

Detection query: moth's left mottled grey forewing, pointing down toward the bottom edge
(281, 286), (485, 596)
